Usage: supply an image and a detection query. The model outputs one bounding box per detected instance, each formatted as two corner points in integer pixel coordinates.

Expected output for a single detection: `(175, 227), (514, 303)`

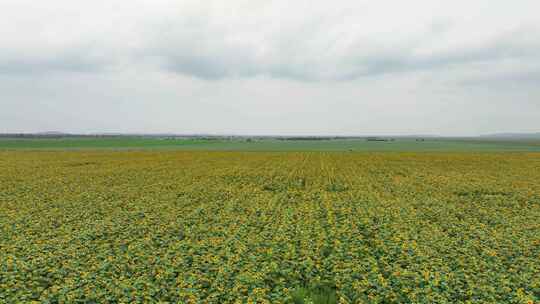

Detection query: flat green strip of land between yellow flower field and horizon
(0, 137), (540, 152)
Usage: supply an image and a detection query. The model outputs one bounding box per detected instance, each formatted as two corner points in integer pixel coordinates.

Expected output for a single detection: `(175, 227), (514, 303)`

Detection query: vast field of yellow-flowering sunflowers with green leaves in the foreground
(0, 151), (540, 303)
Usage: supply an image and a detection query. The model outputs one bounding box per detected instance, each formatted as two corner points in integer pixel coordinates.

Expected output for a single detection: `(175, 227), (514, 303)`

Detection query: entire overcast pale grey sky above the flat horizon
(0, 0), (540, 135)
